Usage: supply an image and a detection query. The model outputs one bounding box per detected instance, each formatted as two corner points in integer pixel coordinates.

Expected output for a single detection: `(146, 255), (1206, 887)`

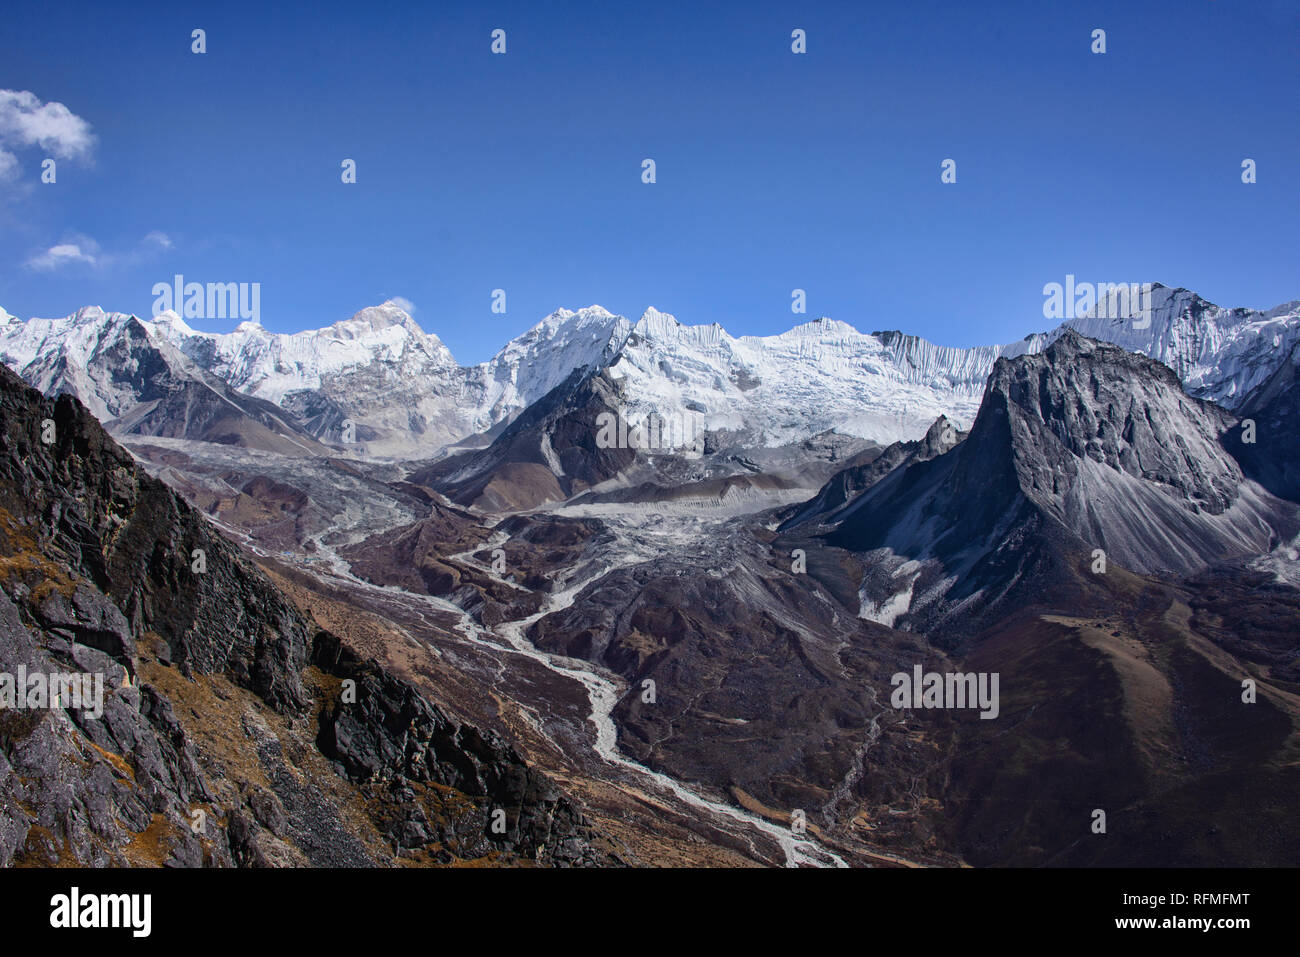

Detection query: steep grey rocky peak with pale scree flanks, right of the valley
(828, 332), (1295, 627)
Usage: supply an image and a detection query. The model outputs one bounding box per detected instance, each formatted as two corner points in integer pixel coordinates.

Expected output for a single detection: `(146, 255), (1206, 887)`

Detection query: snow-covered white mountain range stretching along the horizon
(0, 283), (1300, 460)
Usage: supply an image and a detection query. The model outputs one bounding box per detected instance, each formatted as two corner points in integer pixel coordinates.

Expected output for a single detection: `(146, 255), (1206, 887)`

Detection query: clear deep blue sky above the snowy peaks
(0, 0), (1300, 363)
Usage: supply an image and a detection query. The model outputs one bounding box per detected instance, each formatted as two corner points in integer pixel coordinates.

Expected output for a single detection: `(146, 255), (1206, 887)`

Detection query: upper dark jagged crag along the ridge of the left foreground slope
(0, 356), (308, 707)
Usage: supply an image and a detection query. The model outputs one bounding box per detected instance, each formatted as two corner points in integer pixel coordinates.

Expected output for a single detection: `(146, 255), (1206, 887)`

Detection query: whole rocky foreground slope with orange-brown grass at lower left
(0, 369), (608, 866)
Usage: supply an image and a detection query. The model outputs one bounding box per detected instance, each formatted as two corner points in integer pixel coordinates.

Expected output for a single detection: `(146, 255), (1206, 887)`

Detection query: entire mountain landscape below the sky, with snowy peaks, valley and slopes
(0, 285), (1300, 867)
